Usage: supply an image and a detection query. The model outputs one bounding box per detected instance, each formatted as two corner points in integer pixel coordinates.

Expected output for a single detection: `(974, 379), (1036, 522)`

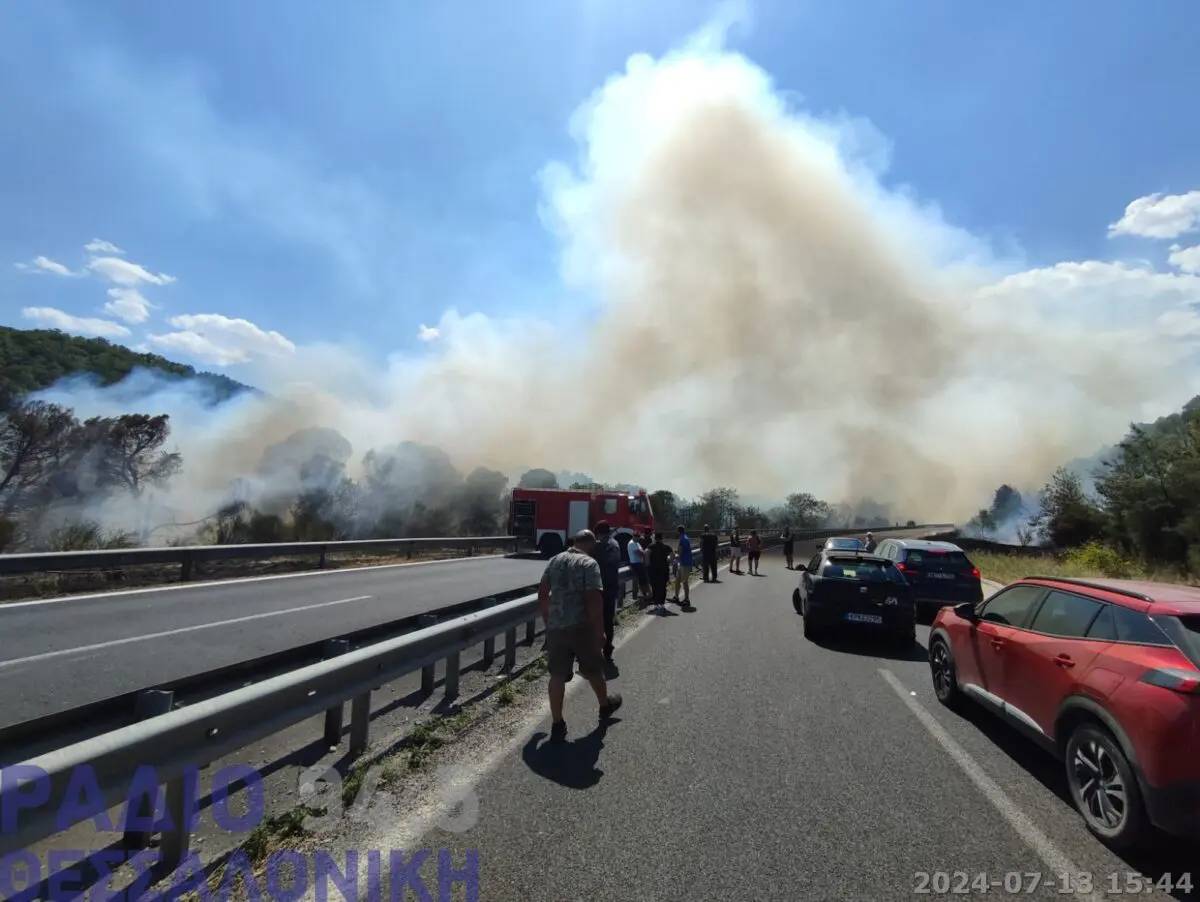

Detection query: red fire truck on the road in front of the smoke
(509, 488), (654, 558)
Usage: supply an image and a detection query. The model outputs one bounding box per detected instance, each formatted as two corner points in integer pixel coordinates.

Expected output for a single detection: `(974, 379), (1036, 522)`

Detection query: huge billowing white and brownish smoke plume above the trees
(30, 19), (1200, 534)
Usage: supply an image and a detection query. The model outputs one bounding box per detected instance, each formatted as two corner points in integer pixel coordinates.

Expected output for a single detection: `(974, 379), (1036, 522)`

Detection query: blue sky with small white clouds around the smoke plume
(0, 0), (1200, 375)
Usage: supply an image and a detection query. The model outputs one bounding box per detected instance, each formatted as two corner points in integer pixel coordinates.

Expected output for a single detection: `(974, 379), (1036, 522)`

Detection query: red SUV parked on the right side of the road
(929, 577), (1200, 848)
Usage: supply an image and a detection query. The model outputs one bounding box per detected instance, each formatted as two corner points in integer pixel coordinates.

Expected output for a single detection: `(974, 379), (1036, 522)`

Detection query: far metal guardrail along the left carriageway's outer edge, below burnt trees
(0, 536), (518, 579)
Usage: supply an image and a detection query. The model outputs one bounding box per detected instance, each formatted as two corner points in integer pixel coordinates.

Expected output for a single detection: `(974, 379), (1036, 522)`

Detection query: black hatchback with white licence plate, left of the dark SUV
(792, 549), (917, 645)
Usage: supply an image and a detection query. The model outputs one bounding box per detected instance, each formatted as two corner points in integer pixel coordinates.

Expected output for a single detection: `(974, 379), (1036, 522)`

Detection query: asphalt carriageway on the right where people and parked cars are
(396, 555), (1200, 901)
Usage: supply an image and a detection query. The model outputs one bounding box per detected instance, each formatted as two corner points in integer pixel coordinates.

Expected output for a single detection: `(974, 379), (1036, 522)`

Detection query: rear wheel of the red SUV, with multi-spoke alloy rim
(1067, 723), (1147, 849)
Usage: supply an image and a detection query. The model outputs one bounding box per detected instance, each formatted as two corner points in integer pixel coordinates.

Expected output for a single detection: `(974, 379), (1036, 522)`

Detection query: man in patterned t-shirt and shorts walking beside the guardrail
(538, 529), (622, 742)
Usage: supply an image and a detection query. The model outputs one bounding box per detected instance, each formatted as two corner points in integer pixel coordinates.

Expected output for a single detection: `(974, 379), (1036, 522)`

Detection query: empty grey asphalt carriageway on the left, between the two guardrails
(0, 557), (542, 727)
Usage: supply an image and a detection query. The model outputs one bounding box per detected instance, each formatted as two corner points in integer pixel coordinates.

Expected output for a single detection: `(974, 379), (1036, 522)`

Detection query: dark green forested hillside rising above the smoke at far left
(0, 326), (253, 408)
